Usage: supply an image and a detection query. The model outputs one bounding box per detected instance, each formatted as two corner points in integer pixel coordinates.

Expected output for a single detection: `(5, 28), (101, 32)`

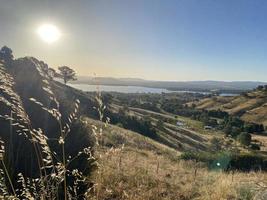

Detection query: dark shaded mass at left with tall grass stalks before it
(0, 57), (96, 199)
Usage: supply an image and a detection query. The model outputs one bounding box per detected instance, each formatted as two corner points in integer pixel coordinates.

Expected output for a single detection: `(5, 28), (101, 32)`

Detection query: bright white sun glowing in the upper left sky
(37, 24), (61, 44)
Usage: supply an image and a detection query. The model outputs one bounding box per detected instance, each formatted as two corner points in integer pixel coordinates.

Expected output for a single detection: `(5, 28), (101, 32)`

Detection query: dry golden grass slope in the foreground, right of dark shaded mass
(85, 118), (267, 200)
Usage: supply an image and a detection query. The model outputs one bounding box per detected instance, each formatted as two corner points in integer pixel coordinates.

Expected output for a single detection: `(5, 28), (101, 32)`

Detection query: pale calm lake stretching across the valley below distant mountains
(68, 84), (239, 96)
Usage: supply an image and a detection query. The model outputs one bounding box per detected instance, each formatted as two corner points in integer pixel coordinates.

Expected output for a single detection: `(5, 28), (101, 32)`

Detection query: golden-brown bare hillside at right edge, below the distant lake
(194, 89), (267, 126)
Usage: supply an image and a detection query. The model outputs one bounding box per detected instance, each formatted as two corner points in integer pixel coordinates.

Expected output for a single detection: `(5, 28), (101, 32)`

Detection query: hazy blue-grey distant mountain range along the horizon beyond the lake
(72, 76), (267, 93)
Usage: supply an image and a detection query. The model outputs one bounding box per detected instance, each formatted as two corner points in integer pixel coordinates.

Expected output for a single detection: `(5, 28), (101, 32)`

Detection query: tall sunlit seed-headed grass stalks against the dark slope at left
(0, 58), (94, 200)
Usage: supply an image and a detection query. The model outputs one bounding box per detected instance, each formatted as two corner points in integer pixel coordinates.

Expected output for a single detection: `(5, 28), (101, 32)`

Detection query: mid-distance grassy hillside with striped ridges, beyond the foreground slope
(109, 105), (218, 151)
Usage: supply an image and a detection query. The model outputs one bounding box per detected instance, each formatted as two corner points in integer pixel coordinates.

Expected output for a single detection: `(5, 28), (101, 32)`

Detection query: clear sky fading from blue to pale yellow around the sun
(0, 0), (267, 81)
